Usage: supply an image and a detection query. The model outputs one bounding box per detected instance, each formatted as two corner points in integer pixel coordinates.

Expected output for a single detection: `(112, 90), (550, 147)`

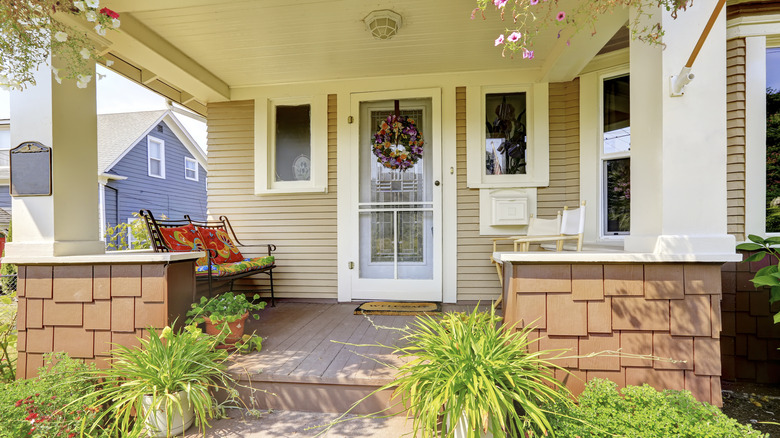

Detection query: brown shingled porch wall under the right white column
(504, 262), (722, 406)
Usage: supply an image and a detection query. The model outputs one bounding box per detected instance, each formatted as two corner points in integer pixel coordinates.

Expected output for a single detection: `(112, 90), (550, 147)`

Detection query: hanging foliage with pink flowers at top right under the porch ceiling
(471, 0), (693, 59)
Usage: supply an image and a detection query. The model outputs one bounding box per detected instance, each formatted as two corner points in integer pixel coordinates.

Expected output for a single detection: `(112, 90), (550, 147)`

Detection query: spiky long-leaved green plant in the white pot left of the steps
(86, 326), (235, 437)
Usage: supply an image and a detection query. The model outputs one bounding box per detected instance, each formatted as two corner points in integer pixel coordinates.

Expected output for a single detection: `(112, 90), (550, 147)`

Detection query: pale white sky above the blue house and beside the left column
(0, 65), (206, 151)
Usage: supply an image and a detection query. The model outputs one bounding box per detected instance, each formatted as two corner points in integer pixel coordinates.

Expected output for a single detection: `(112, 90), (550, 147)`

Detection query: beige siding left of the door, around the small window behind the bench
(208, 95), (337, 298)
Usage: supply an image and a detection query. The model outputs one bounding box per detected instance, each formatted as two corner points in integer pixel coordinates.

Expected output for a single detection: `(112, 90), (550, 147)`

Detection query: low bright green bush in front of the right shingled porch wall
(552, 379), (764, 438)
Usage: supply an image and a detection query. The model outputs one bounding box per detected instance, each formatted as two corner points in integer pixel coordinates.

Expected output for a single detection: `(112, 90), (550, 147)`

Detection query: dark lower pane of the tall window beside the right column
(604, 158), (631, 234)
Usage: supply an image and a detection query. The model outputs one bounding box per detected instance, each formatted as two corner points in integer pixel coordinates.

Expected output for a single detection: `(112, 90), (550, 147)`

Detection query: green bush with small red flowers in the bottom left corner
(0, 353), (108, 438)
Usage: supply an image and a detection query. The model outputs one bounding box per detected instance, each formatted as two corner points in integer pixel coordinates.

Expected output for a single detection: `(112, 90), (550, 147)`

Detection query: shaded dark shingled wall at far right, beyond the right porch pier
(720, 257), (780, 383)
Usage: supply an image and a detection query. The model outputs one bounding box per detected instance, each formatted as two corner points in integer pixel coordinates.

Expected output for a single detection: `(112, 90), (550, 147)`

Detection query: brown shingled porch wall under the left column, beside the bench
(16, 261), (195, 379)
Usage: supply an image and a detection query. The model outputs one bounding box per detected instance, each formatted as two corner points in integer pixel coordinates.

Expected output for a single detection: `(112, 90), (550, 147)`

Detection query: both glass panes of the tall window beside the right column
(600, 75), (631, 236)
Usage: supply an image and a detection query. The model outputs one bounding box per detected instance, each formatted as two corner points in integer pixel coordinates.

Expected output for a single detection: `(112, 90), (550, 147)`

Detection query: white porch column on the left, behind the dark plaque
(6, 60), (105, 256)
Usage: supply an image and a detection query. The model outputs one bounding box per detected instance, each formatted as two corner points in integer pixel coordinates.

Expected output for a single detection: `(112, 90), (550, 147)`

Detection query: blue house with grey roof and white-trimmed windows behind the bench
(98, 110), (207, 245)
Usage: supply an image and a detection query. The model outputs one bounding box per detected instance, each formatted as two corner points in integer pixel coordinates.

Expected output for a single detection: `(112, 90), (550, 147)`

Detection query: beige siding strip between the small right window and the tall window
(537, 79), (580, 217)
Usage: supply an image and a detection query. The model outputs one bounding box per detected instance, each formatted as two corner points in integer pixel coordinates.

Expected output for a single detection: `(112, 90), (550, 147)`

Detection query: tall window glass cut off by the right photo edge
(766, 48), (780, 233)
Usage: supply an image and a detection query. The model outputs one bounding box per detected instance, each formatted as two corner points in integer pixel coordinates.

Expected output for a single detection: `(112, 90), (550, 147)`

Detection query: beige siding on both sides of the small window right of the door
(455, 80), (580, 301)
